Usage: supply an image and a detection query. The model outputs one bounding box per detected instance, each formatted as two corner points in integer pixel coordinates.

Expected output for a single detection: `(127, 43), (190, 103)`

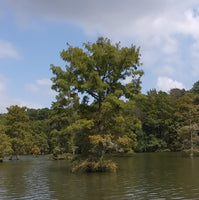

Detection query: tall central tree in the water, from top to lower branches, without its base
(51, 38), (143, 170)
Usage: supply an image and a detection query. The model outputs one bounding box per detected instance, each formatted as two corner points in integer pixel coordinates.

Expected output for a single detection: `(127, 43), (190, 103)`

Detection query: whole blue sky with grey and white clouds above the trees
(0, 0), (199, 113)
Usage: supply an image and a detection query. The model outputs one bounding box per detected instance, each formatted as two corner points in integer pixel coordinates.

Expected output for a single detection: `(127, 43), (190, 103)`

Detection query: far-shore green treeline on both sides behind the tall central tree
(0, 81), (199, 162)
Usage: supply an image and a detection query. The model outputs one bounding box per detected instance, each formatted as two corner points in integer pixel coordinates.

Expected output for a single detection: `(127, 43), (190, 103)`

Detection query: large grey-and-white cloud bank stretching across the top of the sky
(2, 0), (199, 69)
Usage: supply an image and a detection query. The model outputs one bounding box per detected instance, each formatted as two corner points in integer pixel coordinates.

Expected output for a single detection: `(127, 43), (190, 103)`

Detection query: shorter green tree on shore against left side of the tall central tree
(48, 97), (79, 156)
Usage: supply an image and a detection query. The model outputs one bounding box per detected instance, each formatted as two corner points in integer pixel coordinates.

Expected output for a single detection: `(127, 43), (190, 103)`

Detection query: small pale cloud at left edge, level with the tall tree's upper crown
(0, 40), (19, 59)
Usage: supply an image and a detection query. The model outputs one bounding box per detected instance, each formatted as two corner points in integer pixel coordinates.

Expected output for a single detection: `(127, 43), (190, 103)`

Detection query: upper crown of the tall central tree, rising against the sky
(51, 38), (143, 112)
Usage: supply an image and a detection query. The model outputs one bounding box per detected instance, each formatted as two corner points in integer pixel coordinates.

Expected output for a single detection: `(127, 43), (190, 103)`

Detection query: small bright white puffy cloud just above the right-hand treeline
(156, 77), (185, 92)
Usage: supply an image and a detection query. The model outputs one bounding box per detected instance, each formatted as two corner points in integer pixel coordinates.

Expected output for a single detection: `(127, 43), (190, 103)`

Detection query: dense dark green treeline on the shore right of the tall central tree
(135, 85), (199, 152)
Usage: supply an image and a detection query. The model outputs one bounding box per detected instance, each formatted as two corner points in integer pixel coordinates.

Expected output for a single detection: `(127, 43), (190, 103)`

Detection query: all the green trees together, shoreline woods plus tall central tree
(0, 38), (199, 171)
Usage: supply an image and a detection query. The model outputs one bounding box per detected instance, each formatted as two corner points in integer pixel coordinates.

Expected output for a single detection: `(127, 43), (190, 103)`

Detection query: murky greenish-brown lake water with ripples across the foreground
(0, 153), (199, 200)
